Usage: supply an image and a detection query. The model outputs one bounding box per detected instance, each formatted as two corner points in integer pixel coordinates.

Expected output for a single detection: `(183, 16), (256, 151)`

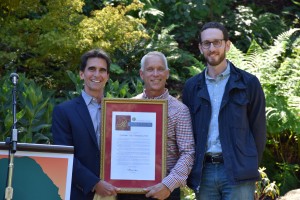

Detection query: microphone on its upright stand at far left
(5, 73), (18, 200)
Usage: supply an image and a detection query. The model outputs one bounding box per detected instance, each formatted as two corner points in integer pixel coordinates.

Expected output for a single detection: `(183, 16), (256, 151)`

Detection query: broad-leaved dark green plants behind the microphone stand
(0, 74), (54, 143)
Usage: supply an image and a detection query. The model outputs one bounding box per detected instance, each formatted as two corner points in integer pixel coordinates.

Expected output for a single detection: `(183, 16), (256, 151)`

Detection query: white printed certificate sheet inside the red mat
(110, 111), (156, 180)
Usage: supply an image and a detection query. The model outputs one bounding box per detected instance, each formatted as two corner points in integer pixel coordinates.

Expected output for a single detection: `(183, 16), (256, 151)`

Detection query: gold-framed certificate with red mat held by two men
(100, 98), (168, 194)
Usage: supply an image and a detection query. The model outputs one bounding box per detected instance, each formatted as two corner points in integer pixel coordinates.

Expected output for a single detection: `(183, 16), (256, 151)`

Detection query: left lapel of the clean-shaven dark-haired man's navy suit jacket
(76, 95), (100, 146)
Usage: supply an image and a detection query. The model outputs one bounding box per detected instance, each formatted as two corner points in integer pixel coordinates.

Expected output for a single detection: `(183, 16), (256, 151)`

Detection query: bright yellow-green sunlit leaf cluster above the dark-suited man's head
(77, 1), (148, 52)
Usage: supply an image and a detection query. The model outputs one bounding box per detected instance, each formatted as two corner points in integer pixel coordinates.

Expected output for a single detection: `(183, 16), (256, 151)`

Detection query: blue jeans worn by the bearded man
(195, 163), (255, 200)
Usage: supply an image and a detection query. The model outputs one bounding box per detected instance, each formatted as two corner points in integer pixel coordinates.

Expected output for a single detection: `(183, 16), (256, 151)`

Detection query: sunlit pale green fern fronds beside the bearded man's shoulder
(228, 29), (300, 132)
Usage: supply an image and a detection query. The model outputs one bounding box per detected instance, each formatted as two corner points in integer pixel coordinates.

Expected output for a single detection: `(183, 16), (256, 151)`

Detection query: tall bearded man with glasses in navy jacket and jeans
(182, 22), (266, 200)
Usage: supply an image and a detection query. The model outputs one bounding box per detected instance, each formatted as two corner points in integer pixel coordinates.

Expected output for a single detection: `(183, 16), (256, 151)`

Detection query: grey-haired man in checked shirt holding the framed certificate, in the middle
(118, 52), (195, 200)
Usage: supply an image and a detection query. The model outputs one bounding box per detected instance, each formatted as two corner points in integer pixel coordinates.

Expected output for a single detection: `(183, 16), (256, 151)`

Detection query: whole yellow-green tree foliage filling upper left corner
(0, 0), (148, 90)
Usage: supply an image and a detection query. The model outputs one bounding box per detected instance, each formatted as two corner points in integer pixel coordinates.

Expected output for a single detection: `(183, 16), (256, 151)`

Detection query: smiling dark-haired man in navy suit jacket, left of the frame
(52, 49), (118, 200)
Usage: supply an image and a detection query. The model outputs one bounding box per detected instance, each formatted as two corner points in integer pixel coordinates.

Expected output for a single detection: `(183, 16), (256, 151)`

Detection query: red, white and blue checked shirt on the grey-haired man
(134, 89), (195, 192)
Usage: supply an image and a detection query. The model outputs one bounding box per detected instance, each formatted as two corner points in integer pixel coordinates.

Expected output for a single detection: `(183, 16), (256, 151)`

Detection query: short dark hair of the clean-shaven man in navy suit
(80, 49), (111, 73)
